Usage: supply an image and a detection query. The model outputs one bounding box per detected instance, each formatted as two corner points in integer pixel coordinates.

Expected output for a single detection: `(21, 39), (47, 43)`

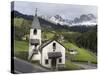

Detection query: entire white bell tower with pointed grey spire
(28, 8), (41, 60)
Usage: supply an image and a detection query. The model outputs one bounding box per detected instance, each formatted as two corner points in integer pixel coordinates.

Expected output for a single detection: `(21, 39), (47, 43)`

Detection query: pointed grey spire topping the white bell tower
(32, 8), (41, 29)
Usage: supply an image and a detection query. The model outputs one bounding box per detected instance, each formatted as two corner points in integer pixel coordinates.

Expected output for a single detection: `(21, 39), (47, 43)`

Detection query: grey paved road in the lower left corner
(14, 57), (50, 73)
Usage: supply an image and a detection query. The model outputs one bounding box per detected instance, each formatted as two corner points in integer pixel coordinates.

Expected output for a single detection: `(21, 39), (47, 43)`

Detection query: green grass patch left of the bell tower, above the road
(14, 40), (28, 60)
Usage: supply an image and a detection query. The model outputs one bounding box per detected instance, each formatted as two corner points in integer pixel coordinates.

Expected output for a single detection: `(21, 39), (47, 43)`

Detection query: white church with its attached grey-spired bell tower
(28, 10), (65, 68)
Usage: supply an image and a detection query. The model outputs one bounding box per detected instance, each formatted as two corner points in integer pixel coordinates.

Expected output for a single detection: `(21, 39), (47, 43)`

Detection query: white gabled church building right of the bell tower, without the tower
(39, 40), (65, 68)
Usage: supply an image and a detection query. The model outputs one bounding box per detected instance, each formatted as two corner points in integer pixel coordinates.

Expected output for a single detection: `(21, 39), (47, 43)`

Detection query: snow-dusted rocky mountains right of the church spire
(42, 14), (97, 26)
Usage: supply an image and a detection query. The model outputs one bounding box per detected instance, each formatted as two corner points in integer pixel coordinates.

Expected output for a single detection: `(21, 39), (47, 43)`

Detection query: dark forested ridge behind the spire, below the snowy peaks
(11, 10), (97, 32)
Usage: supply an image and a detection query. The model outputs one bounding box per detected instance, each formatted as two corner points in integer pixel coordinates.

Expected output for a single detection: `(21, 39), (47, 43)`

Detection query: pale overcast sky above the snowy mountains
(12, 1), (97, 20)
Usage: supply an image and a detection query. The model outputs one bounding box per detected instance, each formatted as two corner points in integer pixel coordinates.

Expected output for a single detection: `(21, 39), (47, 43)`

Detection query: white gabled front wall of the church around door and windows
(42, 41), (65, 68)
